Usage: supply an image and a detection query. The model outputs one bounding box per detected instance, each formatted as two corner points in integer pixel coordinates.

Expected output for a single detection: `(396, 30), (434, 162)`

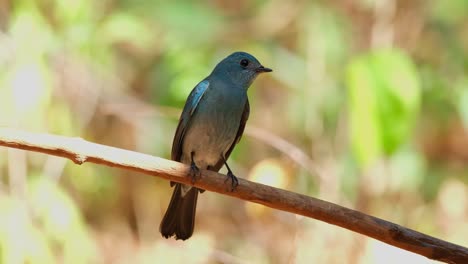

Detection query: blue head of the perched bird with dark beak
(213, 52), (272, 89)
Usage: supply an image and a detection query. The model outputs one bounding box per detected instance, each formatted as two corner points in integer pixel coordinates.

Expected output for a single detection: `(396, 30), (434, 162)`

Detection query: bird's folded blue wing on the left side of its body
(171, 79), (210, 161)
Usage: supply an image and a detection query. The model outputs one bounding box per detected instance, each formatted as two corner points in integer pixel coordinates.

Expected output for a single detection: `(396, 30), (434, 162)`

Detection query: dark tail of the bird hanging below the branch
(159, 183), (198, 240)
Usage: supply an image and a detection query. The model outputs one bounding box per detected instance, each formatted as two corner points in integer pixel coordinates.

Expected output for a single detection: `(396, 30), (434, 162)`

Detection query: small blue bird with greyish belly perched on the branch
(159, 51), (272, 240)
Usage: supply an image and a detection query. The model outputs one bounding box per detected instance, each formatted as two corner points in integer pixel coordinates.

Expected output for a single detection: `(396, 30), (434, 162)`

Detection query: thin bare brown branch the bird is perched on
(0, 128), (468, 263)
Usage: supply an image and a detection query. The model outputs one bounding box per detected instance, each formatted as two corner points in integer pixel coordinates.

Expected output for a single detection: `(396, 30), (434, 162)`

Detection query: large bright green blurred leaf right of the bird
(347, 50), (421, 167)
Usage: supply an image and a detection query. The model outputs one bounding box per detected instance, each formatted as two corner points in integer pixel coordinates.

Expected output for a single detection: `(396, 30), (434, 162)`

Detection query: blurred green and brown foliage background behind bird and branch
(0, 0), (468, 263)
